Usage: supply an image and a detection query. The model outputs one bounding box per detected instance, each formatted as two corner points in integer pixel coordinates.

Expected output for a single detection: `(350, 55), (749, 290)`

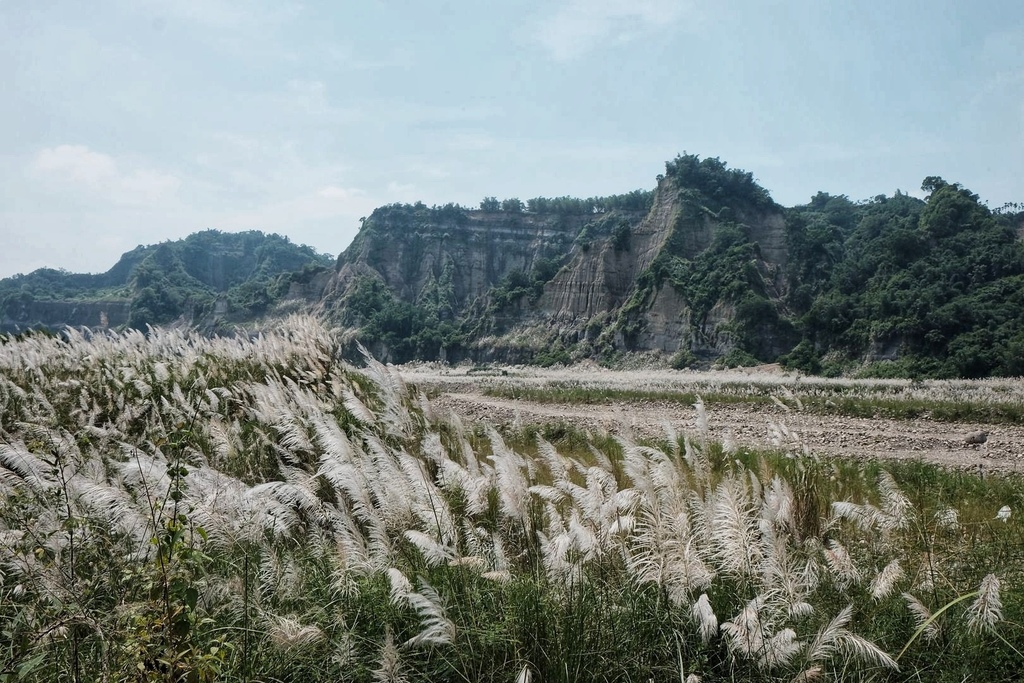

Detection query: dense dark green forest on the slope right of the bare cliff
(787, 178), (1024, 378)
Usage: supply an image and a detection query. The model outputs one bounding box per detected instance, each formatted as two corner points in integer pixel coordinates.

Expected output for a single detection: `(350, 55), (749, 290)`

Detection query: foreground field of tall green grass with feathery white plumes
(0, 318), (1024, 681)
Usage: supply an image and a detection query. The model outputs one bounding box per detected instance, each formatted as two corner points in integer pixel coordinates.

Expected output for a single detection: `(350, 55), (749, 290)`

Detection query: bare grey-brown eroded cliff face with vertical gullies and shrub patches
(319, 169), (788, 360)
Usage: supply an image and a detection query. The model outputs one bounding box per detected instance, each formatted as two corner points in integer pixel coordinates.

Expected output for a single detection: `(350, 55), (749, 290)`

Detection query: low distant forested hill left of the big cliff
(0, 230), (331, 333)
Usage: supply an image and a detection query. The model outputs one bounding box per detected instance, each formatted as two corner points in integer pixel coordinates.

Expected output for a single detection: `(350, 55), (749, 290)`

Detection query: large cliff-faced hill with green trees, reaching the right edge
(318, 155), (1024, 377)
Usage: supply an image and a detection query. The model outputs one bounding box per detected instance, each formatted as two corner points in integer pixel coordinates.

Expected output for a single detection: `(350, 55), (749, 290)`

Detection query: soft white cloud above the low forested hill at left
(29, 144), (181, 206)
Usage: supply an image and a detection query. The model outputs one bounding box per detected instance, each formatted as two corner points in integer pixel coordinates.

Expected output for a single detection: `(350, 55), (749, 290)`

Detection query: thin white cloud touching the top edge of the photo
(538, 0), (689, 61)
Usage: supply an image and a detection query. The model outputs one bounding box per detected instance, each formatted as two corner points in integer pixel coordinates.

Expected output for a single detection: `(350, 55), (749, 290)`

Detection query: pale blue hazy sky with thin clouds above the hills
(0, 0), (1024, 276)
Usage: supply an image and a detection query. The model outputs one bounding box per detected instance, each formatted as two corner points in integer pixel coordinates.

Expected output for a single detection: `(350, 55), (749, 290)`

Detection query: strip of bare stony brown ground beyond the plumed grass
(401, 369), (1024, 472)
